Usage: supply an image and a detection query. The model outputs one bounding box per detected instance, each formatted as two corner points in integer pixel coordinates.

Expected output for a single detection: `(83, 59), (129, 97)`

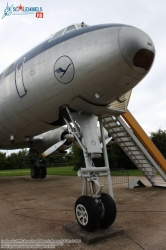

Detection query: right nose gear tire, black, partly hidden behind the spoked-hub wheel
(100, 193), (117, 228)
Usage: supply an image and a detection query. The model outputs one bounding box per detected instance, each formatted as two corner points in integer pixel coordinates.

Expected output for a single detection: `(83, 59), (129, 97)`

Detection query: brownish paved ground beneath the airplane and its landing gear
(0, 176), (166, 250)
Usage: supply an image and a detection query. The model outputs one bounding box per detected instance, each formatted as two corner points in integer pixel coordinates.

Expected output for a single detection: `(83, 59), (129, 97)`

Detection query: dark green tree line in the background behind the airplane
(0, 129), (166, 170)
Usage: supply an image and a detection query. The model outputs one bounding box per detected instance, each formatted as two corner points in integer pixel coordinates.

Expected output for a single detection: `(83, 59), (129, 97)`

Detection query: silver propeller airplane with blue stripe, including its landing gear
(0, 22), (155, 232)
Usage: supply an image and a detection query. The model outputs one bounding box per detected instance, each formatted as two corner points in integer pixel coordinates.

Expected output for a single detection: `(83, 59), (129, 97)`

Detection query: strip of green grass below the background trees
(0, 166), (143, 177)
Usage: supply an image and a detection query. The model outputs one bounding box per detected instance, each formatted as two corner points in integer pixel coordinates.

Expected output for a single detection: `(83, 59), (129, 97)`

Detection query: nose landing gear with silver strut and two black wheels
(62, 107), (116, 232)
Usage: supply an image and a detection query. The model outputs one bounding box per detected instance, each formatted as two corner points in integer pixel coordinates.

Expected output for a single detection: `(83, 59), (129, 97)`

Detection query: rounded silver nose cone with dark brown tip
(119, 27), (155, 74)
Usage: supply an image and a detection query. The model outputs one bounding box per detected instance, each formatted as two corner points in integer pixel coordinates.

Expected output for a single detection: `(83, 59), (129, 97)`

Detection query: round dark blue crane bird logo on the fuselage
(54, 56), (75, 84)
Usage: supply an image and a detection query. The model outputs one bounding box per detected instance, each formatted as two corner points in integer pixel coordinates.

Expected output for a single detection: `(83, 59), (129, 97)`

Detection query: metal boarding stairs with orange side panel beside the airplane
(102, 111), (166, 187)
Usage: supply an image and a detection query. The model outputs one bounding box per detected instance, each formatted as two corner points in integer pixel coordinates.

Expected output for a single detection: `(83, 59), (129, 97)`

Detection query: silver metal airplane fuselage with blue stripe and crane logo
(0, 24), (155, 149)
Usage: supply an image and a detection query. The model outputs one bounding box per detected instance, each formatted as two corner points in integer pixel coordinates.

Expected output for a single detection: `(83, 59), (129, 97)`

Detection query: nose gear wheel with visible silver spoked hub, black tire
(75, 195), (101, 232)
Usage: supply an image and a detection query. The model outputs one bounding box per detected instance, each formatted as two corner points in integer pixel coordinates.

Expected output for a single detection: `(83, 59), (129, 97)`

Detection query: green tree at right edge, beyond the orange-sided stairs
(150, 129), (166, 158)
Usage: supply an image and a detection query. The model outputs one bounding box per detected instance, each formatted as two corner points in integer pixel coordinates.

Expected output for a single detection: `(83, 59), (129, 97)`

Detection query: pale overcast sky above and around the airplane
(0, 0), (166, 136)
